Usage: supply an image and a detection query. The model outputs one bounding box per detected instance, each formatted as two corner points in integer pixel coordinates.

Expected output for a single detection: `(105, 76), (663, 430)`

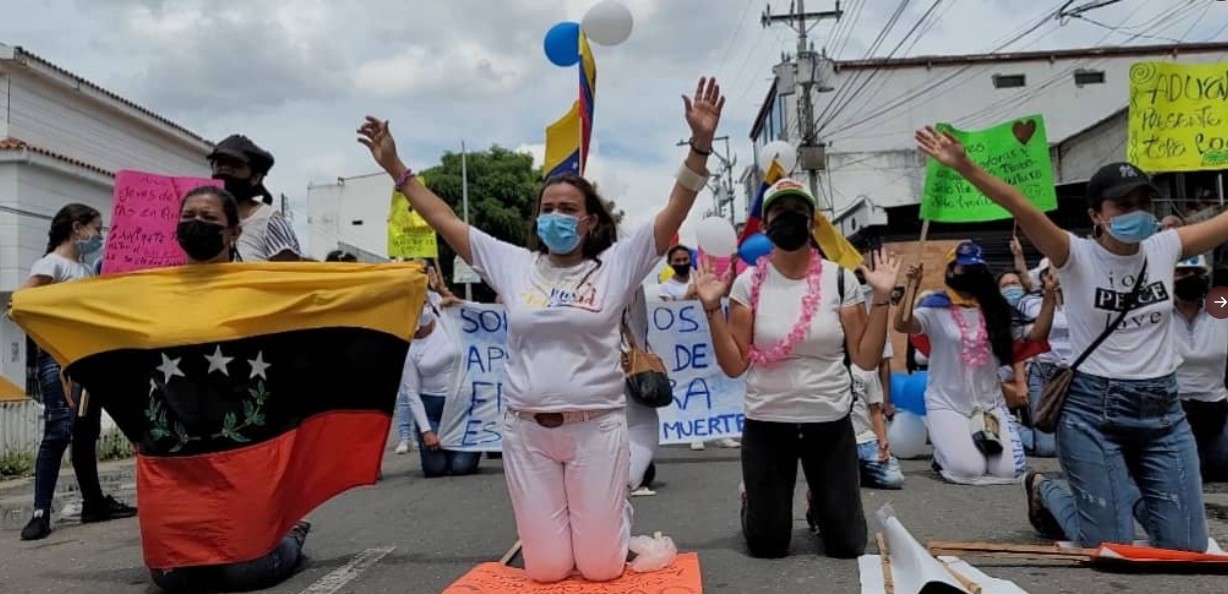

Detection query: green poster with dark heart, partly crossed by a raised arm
(921, 115), (1057, 222)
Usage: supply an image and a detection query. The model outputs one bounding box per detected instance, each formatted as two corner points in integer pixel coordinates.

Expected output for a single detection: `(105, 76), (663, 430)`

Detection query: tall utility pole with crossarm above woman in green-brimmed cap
(759, 0), (844, 211)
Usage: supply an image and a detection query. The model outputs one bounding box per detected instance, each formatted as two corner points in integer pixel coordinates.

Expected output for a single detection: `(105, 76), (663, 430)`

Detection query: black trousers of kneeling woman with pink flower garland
(742, 416), (868, 558)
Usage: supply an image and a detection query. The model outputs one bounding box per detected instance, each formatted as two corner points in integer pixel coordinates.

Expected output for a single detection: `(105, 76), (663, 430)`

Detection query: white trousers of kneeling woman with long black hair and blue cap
(926, 409), (1024, 485)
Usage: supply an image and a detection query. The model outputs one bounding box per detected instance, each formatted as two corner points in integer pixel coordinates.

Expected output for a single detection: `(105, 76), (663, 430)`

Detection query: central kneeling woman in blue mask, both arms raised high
(359, 79), (717, 582)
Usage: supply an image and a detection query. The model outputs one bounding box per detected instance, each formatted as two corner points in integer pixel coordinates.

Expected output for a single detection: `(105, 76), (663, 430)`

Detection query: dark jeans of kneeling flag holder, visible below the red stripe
(150, 533), (303, 593)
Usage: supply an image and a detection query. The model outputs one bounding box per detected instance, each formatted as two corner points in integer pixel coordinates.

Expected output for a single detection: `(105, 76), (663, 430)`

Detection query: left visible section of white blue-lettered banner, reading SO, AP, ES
(438, 303), (507, 452)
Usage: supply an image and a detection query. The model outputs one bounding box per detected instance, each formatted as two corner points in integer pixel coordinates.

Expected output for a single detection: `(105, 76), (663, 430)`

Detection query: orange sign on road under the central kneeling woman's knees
(443, 552), (704, 594)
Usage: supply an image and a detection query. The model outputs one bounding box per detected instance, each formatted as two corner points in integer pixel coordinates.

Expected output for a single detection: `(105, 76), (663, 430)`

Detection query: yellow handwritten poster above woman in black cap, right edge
(1126, 61), (1228, 173)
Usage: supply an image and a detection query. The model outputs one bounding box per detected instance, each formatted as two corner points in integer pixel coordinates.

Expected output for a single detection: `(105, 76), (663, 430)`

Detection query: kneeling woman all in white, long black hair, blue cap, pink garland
(895, 242), (1055, 485)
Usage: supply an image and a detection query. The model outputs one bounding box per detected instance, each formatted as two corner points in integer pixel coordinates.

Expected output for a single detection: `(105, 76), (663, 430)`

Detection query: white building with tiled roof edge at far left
(0, 44), (212, 414)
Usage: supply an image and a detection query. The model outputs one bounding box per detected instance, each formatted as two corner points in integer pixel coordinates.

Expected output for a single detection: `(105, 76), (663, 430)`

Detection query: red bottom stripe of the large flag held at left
(136, 411), (392, 569)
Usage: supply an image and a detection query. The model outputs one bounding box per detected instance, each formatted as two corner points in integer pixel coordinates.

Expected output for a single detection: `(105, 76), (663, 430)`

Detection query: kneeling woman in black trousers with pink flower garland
(695, 179), (899, 558)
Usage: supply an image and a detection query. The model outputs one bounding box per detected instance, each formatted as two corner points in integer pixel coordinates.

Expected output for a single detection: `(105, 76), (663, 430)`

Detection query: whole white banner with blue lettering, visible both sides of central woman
(438, 301), (747, 452)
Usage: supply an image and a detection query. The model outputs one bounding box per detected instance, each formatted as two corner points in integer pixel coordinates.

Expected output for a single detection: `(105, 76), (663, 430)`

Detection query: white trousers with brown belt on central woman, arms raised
(503, 411), (631, 583)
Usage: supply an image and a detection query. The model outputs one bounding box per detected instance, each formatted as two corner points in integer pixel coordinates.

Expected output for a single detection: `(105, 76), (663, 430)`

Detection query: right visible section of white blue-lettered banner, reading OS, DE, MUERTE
(648, 301), (747, 446)
